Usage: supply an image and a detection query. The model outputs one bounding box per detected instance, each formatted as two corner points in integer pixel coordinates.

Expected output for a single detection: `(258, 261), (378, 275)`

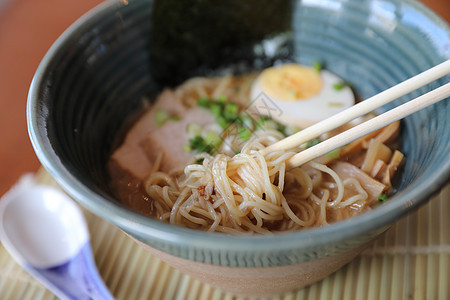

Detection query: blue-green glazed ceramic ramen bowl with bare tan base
(27, 0), (450, 295)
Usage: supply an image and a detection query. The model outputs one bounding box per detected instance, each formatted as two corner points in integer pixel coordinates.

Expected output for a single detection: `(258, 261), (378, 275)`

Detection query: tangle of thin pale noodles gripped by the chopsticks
(145, 133), (367, 233)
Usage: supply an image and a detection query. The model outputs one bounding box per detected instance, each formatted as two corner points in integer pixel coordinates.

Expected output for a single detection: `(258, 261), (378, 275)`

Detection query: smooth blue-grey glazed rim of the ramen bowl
(26, 0), (450, 253)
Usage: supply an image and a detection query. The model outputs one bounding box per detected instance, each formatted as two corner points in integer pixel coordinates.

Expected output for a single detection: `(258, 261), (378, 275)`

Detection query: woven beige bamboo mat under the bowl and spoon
(0, 171), (450, 300)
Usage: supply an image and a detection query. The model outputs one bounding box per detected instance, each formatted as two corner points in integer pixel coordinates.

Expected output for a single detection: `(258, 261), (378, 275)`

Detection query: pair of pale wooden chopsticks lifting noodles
(261, 60), (450, 168)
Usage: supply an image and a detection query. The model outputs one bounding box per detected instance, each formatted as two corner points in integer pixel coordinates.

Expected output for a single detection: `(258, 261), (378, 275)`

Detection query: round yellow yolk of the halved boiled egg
(260, 64), (322, 101)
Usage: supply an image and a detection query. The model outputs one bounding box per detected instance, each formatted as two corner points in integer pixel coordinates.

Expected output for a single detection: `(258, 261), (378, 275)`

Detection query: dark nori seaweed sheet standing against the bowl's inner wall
(149, 0), (294, 85)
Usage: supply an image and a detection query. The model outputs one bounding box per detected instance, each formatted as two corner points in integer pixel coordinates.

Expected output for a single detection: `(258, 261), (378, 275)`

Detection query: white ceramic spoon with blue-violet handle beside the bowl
(0, 178), (113, 300)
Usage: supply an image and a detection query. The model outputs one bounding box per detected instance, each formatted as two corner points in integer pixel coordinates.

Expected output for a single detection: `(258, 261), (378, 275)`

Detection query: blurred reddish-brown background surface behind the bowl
(0, 0), (450, 196)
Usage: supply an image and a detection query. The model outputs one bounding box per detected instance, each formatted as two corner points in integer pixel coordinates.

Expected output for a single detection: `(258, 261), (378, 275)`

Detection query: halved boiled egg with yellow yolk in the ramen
(250, 64), (355, 127)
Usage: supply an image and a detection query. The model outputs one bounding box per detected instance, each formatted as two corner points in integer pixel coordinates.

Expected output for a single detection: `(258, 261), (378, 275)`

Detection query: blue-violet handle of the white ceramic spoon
(27, 242), (114, 300)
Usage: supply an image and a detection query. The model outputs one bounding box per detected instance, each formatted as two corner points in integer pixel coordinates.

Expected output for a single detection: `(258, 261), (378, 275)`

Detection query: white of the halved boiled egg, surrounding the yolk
(250, 67), (355, 128)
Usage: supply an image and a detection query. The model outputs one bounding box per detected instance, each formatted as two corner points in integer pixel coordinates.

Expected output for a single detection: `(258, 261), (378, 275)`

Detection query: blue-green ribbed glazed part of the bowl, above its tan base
(27, 0), (450, 267)
